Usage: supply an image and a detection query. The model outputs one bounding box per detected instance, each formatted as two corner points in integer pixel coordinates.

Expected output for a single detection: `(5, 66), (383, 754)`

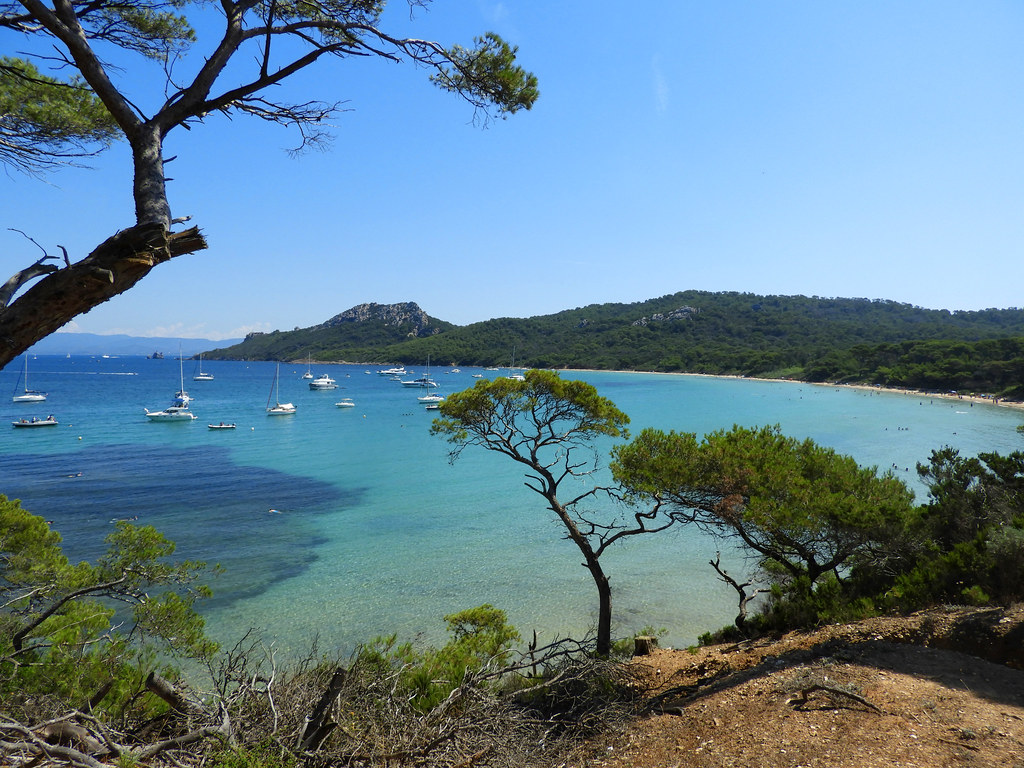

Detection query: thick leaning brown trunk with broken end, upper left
(0, 223), (206, 368)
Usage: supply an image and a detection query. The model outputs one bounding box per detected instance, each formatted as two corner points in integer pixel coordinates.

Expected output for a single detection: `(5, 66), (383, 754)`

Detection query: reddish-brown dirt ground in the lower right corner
(566, 605), (1024, 768)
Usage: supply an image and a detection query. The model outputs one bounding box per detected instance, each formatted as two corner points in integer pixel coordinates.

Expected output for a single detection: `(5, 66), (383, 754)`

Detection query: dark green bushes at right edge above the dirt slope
(688, 447), (1024, 641)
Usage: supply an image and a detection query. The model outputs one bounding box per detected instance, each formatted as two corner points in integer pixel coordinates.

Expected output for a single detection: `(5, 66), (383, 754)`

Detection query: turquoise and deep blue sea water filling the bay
(0, 355), (1024, 657)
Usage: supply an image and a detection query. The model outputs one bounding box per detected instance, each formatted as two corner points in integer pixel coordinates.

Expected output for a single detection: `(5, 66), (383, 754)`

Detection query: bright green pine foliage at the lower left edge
(0, 497), (216, 717)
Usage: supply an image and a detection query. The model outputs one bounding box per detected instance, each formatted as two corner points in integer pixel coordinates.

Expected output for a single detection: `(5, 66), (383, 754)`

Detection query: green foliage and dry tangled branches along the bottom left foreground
(0, 500), (641, 768)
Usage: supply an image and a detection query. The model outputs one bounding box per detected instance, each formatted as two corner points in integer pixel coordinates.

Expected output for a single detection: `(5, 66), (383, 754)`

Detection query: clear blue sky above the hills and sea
(0, 0), (1024, 338)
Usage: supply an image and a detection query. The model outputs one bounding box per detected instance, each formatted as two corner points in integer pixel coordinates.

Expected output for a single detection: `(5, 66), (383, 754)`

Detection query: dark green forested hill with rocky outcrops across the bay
(207, 291), (1024, 397)
